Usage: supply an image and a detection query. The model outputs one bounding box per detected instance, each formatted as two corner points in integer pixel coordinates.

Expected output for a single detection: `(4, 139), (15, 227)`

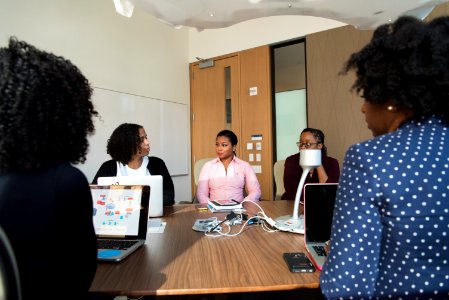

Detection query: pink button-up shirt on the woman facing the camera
(196, 156), (261, 203)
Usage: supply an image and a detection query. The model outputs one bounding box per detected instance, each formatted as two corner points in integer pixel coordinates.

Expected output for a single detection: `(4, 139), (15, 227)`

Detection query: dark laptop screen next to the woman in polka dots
(304, 183), (338, 243)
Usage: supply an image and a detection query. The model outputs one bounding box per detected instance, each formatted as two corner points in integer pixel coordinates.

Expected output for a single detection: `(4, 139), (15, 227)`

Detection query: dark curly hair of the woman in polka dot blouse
(342, 17), (449, 121)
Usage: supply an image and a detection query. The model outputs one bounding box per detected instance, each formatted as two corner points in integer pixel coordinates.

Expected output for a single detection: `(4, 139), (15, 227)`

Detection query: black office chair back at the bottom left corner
(0, 227), (22, 300)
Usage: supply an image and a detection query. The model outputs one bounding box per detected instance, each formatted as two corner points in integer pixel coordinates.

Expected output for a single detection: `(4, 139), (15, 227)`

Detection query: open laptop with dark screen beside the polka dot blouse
(304, 183), (338, 270)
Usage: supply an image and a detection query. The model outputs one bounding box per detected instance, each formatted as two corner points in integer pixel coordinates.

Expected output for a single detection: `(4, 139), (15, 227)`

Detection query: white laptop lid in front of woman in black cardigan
(97, 175), (164, 218)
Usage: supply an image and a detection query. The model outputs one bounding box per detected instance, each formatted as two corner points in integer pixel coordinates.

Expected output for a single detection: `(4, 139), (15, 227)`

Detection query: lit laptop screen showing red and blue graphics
(90, 185), (150, 238)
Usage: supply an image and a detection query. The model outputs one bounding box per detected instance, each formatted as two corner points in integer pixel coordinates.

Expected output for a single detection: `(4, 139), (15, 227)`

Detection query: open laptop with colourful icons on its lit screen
(90, 185), (150, 261)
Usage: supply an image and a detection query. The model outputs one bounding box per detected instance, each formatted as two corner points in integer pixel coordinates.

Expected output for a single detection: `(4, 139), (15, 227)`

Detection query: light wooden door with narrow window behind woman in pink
(190, 55), (241, 193)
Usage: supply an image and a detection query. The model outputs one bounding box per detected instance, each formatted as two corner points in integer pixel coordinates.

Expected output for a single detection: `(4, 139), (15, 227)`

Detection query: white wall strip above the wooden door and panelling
(189, 16), (347, 62)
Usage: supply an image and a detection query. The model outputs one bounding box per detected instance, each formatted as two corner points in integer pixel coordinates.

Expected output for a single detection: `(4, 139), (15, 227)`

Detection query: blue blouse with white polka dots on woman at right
(320, 117), (449, 299)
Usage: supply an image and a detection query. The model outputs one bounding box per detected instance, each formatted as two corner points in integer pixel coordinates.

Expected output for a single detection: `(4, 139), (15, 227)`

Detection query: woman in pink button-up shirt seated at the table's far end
(196, 130), (261, 203)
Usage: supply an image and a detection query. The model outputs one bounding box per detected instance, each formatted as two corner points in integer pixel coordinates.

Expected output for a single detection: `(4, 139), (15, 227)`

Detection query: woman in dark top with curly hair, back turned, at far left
(0, 38), (97, 300)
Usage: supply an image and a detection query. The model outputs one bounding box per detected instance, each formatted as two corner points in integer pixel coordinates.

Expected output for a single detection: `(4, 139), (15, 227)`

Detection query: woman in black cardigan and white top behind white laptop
(92, 123), (175, 206)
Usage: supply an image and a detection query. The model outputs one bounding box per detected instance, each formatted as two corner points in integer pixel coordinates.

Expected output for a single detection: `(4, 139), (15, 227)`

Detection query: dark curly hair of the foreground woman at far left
(0, 37), (98, 173)
